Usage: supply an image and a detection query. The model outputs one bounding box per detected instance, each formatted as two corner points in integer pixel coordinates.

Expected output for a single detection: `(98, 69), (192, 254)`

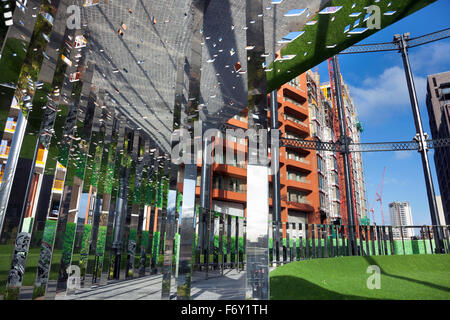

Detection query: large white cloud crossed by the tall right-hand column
(350, 66), (426, 122)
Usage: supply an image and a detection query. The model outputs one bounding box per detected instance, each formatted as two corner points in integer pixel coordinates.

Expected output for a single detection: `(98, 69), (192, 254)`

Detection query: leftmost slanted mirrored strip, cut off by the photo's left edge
(0, 3), (67, 239)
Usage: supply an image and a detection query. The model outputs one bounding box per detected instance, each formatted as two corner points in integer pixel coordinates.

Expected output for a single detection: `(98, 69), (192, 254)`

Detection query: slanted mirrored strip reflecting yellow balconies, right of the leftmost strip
(13, 34), (90, 296)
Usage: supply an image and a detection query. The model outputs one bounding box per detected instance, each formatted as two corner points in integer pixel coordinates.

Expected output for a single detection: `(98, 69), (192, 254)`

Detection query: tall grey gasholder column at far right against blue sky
(394, 33), (442, 252)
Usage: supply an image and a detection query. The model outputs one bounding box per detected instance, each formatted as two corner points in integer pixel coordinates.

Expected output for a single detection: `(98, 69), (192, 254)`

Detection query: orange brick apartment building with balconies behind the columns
(174, 71), (365, 224)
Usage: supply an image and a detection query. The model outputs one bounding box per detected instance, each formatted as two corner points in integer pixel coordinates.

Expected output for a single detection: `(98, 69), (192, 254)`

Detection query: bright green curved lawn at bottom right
(270, 255), (450, 300)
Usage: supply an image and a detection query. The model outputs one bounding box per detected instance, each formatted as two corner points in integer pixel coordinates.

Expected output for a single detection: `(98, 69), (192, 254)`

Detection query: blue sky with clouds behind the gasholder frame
(319, 0), (450, 225)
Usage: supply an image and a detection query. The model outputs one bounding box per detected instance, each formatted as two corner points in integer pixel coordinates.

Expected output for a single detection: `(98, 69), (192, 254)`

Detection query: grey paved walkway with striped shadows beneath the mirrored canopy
(56, 270), (245, 300)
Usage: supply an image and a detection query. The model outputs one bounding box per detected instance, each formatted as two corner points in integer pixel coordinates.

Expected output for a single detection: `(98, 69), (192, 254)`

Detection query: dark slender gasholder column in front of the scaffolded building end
(333, 56), (356, 255)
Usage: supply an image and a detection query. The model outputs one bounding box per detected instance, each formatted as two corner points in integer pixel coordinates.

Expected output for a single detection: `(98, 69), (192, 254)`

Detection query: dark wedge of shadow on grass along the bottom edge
(270, 276), (379, 300)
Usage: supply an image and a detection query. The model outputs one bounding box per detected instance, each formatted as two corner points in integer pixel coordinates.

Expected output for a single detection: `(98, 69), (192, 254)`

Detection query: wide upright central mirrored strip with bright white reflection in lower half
(246, 0), (269, 300)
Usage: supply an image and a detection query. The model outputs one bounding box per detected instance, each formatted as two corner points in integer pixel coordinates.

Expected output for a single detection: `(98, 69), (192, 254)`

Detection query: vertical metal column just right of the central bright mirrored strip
(270, 90), (281, 262)
